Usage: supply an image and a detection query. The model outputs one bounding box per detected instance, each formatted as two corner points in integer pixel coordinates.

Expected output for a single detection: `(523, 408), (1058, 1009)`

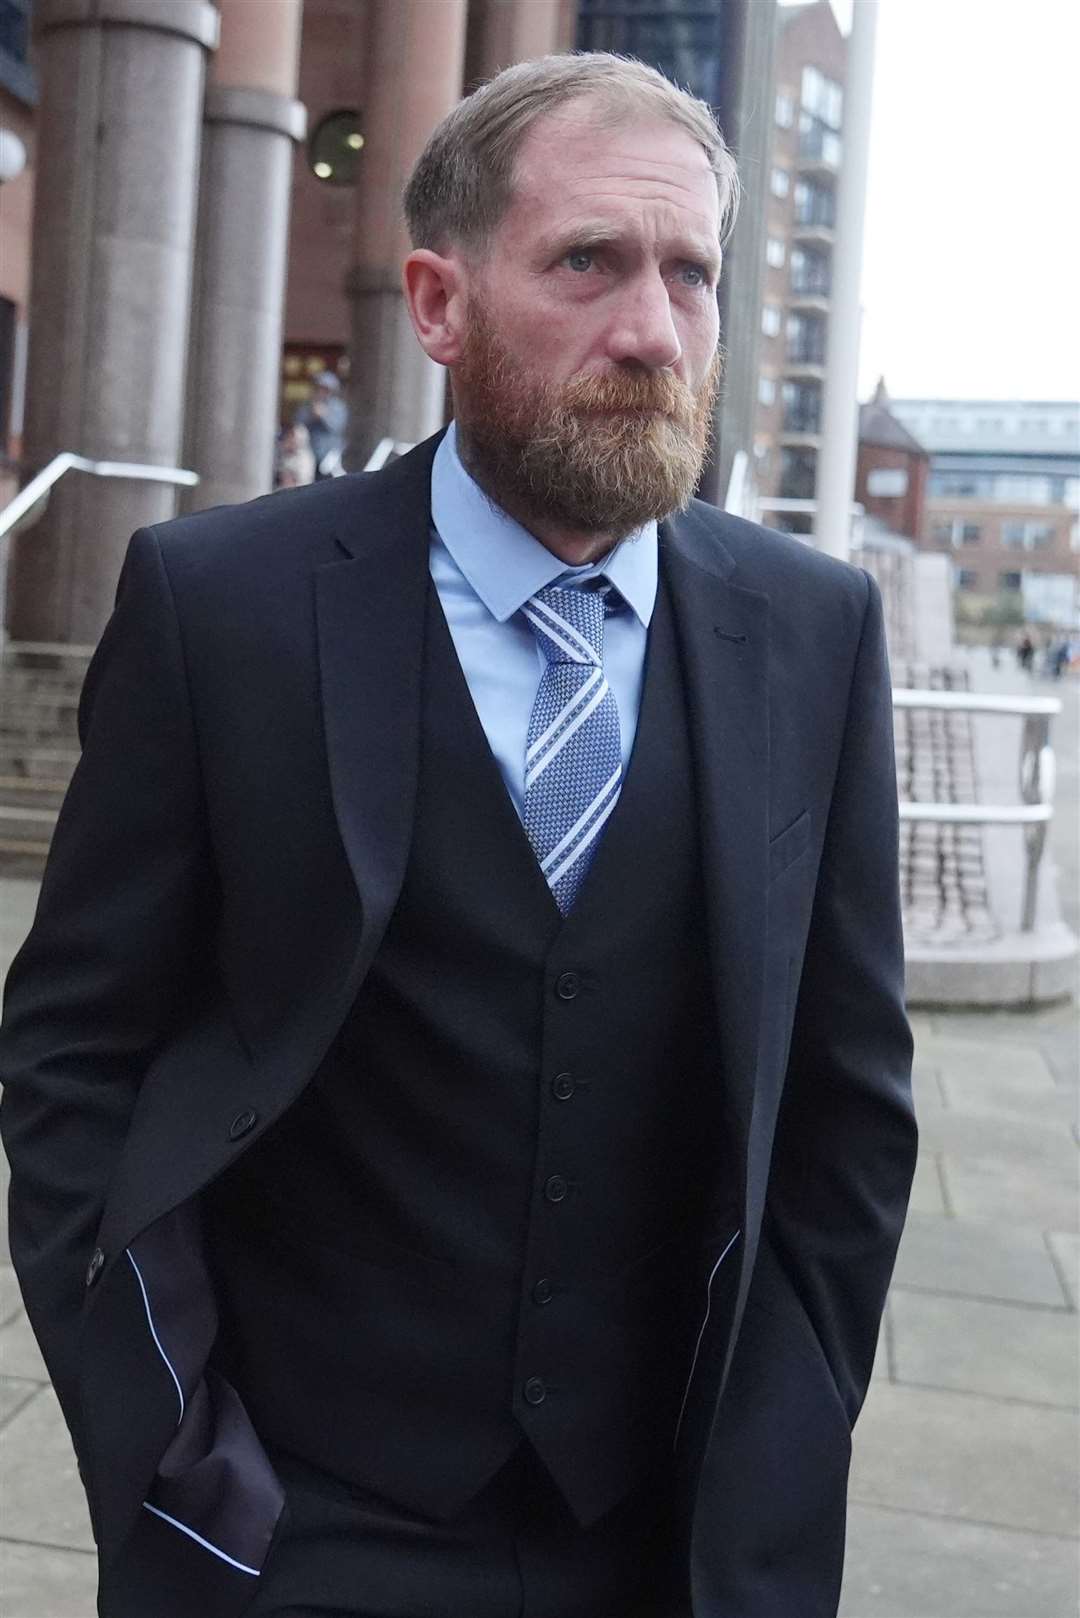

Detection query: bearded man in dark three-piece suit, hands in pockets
(0, 55), (915, 1618)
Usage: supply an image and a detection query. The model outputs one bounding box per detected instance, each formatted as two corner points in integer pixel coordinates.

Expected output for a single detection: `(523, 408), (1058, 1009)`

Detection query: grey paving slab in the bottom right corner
(840, 1506), (1080, 1618)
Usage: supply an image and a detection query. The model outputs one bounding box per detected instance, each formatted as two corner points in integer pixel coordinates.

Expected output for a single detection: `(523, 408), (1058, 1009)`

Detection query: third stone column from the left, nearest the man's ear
(345, 0), (466, 471)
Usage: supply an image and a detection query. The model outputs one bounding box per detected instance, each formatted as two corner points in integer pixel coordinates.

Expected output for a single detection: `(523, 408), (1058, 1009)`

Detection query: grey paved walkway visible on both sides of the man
(0, 883), (1080, 1618)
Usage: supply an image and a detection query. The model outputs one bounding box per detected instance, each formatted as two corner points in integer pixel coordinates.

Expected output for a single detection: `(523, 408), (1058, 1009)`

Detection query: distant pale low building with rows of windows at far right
(891, 400), (1080, 623)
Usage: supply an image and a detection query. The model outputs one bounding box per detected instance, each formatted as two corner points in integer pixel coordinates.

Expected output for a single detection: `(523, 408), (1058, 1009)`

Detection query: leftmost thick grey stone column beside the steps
(8, 0), (217, 644)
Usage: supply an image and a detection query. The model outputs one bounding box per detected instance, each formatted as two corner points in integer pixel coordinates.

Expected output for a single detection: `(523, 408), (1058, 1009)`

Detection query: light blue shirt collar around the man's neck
(431, 422), (657, 628)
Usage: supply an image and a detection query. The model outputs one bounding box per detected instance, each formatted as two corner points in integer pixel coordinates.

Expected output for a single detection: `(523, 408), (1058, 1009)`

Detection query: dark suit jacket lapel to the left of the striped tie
(316, 440), (436, 971)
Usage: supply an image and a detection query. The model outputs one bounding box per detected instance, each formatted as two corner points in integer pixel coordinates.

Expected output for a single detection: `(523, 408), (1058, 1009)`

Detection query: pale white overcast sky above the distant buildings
(780, 0), (1080, 400)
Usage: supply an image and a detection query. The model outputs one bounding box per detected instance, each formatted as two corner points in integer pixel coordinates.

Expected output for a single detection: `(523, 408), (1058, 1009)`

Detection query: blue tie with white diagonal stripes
(523, 584), (622, 916)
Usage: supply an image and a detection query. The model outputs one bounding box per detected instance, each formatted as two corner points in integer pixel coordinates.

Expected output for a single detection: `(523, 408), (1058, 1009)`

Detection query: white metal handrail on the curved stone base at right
(892, 689), (1061, 932)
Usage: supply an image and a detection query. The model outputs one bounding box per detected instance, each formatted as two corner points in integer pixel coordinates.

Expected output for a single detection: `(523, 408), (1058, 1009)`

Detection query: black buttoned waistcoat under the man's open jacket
(207, 569), (716, 1523)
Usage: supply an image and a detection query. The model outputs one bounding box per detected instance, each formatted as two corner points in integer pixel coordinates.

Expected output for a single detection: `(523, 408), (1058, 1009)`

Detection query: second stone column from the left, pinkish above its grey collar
(185, 0), (306, 510)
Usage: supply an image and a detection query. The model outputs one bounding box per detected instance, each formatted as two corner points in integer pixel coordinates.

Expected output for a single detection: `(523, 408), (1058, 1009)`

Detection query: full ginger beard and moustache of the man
(453, 298), (722, 540)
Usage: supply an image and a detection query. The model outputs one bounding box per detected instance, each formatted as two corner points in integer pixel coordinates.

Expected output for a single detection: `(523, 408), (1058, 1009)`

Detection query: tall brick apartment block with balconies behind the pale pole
(753, 0), (847, 532)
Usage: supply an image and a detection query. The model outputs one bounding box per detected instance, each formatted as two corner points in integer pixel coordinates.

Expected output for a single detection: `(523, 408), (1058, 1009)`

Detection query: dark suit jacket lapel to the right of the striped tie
(662, 510), (769, 1152)
